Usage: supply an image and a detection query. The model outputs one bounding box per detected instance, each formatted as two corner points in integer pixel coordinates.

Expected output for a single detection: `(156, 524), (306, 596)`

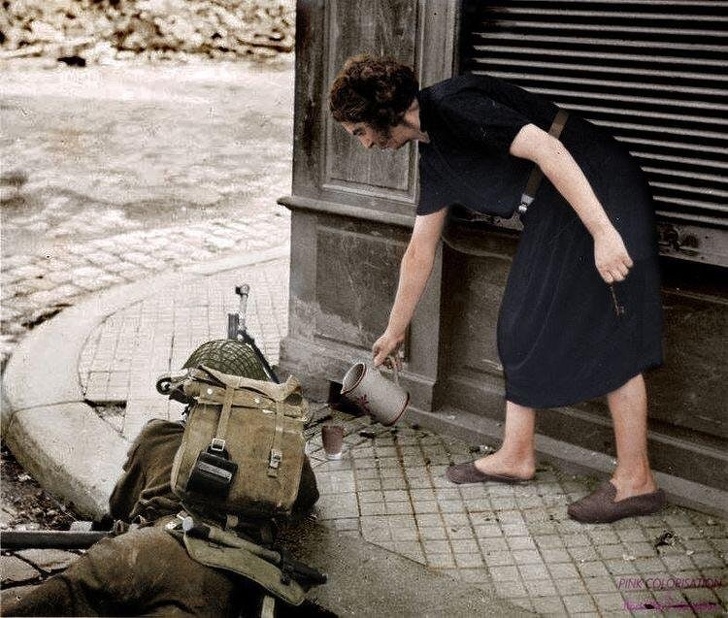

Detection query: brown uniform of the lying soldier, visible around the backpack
(2, 420), (319, 618)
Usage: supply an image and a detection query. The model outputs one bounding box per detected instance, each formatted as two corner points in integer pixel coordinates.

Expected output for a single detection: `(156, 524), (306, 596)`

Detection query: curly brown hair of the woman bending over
(329, 54), (419, 130)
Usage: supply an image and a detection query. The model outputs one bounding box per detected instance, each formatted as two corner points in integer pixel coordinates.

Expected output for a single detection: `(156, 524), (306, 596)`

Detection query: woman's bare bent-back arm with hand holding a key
(510, 124), (632, 283)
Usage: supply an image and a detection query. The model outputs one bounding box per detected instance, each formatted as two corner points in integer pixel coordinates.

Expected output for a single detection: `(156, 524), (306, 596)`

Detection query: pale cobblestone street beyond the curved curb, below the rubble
(0, 60), (293, 364)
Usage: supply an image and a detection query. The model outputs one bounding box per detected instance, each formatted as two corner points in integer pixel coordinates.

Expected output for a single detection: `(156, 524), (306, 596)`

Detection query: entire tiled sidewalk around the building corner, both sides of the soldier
(79, 259), (728, 616)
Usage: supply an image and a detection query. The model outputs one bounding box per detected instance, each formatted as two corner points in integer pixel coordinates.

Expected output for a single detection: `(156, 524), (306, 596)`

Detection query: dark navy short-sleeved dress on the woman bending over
(417, 75), (662, 408)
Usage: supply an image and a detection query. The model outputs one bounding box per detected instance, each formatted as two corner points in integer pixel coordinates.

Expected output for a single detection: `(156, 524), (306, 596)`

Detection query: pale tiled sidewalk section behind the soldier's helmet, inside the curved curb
(79, 258), (288, 440)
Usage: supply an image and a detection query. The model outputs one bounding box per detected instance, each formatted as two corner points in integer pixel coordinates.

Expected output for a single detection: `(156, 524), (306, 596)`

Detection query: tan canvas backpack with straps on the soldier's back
(171, 365), (308, 519)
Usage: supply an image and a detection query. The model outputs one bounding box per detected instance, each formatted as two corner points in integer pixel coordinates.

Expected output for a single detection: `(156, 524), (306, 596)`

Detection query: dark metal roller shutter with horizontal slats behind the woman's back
(460, 0), (728, 266)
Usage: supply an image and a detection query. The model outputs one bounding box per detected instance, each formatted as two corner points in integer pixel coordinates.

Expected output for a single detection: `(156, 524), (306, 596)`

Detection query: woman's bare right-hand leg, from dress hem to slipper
(607, 374), (657, 500)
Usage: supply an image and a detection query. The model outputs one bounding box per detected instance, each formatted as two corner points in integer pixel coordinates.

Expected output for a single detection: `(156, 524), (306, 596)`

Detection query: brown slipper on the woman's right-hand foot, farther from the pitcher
(566, 481), (667, 524)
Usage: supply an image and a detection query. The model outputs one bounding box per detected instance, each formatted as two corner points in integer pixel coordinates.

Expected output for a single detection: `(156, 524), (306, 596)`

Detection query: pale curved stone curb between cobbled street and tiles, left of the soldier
(0, 243), (289, 518)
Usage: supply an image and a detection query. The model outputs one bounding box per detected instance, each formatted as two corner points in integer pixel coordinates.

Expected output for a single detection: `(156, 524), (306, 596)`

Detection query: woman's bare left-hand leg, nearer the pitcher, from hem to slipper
(475, 401), (536, 479)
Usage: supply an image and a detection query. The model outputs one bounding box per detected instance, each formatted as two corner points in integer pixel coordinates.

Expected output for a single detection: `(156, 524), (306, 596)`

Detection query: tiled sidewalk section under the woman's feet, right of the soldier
(309, 412), (728, 616)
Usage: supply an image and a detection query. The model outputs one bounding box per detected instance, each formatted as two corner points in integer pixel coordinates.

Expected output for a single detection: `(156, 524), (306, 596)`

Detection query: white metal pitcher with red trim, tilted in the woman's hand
(341, 361), (409, 427)
